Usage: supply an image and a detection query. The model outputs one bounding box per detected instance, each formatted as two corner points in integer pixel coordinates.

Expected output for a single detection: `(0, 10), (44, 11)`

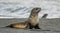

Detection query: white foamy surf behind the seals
(0, 0), (60, 19)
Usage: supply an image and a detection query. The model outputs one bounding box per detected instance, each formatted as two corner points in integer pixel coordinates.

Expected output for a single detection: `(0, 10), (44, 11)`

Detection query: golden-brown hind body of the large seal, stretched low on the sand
(6, 22), (28, 29)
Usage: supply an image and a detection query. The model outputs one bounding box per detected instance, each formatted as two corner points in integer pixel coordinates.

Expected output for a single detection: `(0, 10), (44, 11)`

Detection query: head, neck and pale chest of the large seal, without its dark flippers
(28, 8), (41, 25)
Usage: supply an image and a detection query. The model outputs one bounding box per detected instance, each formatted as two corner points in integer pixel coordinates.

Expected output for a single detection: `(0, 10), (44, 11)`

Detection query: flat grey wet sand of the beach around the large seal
(0, 18), (60, 33)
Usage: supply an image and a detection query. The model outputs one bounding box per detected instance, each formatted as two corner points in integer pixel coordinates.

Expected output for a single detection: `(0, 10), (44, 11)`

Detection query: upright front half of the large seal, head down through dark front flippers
(28, 8), (41, 29)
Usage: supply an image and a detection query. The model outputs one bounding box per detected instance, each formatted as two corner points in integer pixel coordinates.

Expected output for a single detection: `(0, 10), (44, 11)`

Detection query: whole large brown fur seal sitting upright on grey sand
(6, 7), (41, 29)
